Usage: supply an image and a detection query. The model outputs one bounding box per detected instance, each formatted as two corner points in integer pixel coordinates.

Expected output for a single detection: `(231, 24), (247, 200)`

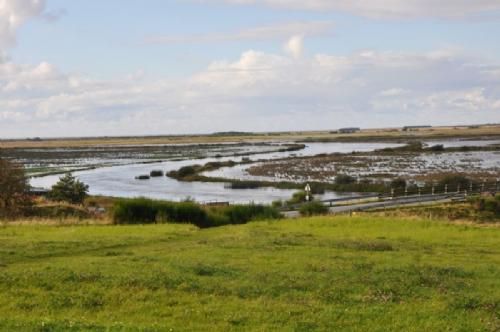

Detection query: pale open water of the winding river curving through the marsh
(31, 143), (399, 203)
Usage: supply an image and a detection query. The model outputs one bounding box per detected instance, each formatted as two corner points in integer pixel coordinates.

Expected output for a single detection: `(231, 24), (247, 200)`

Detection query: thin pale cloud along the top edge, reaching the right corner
(202, 0), (500, 19)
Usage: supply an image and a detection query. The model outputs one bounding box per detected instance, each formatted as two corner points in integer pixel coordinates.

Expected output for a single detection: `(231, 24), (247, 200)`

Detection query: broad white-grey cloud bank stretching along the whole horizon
(0, 46), (500, 137)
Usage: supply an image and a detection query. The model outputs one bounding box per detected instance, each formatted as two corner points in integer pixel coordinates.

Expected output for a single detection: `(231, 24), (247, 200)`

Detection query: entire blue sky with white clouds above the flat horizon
(0, 0), (500, 138)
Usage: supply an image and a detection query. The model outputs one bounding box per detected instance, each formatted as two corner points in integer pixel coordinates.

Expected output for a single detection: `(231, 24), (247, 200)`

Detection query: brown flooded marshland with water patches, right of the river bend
(204, 140), (500, 183)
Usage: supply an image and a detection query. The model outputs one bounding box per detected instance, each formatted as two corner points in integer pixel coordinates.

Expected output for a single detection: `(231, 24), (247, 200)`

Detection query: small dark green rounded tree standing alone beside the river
(49, 173), (89, 204)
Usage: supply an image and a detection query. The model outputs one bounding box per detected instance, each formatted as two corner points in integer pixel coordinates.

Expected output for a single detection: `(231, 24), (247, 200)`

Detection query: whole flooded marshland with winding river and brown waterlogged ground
(26, 140), (500, 203)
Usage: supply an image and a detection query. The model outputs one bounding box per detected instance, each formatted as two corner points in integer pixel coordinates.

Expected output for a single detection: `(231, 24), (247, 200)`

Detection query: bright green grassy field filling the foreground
(0, 217), (500, 331)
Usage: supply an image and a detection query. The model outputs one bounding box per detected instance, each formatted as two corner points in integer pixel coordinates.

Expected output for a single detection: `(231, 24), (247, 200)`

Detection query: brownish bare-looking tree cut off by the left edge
(0, 158), (31, 218)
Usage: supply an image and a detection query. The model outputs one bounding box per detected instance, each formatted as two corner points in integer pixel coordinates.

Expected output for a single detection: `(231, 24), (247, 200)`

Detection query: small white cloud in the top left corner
(0, 0), (45, 49)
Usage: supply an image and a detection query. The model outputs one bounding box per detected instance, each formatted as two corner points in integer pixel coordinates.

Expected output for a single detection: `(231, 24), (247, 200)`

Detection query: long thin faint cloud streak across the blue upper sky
(146, 21), (333, 44)
